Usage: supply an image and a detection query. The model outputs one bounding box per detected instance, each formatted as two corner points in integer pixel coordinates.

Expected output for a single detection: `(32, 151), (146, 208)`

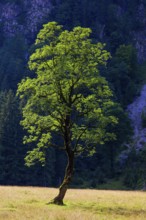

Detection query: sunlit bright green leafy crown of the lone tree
(18, 22), (117, 167)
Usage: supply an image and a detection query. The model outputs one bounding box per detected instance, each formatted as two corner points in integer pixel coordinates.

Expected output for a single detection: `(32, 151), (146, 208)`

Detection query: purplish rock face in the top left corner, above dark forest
(0, 0), (52, 37)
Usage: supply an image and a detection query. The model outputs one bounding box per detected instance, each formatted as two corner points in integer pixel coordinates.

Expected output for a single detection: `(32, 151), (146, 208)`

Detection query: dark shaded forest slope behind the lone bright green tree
(0, 0), (146, 189)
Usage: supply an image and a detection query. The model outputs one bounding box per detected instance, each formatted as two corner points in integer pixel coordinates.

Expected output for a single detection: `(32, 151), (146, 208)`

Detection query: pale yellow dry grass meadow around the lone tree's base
(0, 187), (146, 220)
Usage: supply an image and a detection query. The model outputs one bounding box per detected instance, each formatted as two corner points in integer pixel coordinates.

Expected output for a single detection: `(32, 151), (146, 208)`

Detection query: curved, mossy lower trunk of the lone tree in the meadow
(50, 150), (74, 205)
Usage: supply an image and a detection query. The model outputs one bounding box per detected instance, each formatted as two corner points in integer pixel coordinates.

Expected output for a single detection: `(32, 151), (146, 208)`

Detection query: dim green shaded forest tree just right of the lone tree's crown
(105, 45), (139, 108)
